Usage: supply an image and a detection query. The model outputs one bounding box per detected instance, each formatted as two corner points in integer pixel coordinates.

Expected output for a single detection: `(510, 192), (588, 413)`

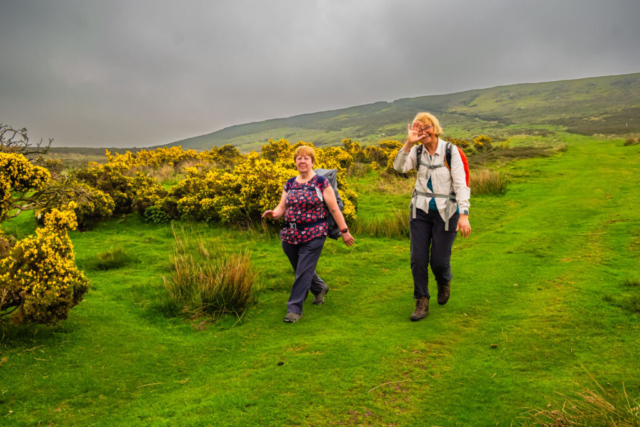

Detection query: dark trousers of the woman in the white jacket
(410, 209), (460, 299)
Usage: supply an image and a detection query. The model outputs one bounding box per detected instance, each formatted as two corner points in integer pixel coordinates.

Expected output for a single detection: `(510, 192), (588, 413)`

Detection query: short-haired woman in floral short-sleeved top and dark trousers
(262, 145), (354, 323)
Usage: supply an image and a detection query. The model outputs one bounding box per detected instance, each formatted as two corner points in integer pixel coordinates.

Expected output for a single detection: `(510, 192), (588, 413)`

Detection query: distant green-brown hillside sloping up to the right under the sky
(156, 73), (640, 152)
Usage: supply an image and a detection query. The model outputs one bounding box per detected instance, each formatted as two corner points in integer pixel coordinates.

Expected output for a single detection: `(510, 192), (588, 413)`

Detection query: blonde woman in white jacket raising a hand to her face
(393, 113), (471, 321)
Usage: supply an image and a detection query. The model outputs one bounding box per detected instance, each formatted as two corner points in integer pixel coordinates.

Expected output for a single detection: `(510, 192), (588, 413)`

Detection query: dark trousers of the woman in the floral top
(282, 236), (327, 314)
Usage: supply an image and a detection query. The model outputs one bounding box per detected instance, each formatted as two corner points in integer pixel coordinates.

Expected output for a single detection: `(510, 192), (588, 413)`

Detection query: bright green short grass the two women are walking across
(0, 134), (640, 426)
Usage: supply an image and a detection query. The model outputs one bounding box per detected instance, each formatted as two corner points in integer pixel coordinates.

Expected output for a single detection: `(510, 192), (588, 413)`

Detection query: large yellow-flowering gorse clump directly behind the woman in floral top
(154, 140), (357, 224)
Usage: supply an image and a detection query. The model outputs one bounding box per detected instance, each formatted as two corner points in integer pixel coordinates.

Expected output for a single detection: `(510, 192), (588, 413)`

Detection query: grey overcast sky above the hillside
(0, 0), (640, 147)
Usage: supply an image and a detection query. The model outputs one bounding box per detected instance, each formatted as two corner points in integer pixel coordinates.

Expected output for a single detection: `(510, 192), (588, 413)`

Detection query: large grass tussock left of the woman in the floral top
(163, 229), (257, 317)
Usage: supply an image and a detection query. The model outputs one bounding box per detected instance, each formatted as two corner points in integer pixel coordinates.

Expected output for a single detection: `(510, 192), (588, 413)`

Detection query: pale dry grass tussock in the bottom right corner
(523, 383), (640, 427)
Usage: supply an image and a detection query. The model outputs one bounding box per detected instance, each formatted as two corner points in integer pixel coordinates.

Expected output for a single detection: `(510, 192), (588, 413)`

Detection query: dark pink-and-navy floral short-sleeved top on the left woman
(280, 175), (331, 245)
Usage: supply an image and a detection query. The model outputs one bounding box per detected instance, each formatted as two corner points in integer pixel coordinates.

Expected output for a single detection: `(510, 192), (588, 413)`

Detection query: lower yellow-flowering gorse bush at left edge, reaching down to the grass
(0, 206), (89, 325)
